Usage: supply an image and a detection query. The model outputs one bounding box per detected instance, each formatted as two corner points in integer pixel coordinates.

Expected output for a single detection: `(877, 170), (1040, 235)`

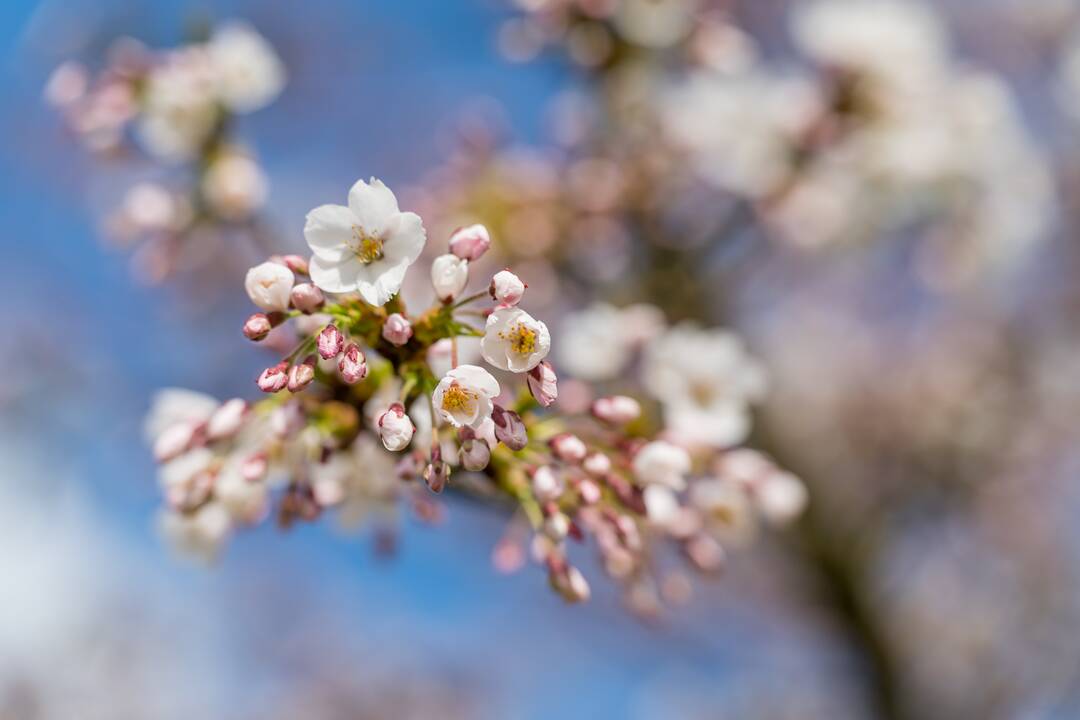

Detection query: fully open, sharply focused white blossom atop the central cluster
(303, 178), (427, 305)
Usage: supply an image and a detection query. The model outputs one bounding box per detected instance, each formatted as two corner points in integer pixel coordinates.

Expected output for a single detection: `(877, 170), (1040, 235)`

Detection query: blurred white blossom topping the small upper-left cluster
(206, 23), (285, 112)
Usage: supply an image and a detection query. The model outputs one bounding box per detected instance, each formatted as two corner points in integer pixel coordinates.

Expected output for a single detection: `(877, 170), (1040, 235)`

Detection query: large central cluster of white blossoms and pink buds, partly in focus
(147, 179), (806, 609)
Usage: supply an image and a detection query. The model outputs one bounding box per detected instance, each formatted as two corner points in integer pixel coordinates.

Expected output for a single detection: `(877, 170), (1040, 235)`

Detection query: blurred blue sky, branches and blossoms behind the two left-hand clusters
(6, 0), (1080, 720)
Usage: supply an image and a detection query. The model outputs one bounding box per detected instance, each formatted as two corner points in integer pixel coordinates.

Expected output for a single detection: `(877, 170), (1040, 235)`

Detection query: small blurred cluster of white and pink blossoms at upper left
(45, 23), (285, 279)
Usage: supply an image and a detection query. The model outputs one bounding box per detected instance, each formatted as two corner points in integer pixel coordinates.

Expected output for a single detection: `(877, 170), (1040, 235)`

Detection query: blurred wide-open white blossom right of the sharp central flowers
(644, 324), (766, 447)
